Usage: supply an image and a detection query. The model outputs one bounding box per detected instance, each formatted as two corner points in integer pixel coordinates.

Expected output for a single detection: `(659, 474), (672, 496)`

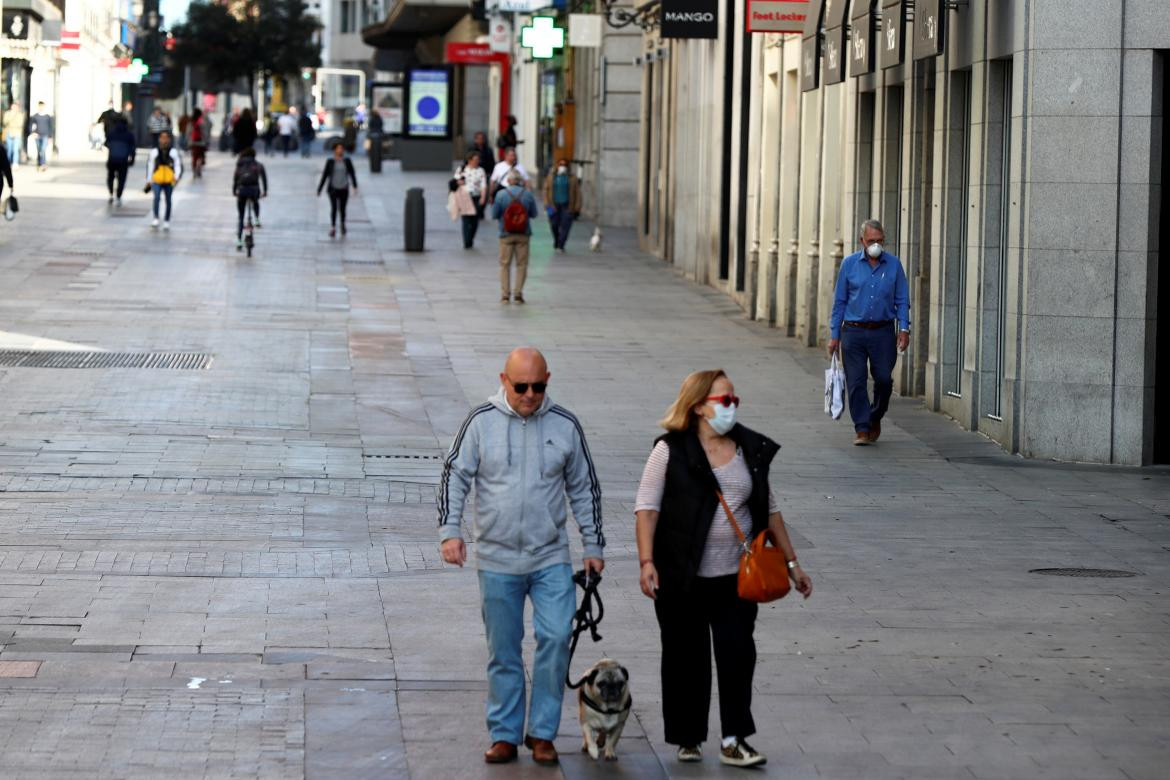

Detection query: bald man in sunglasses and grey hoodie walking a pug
(439, 347), (605, 765)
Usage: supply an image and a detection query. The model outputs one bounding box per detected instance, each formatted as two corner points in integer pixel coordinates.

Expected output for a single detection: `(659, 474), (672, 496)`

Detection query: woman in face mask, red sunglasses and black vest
(634, 371), (812, 766)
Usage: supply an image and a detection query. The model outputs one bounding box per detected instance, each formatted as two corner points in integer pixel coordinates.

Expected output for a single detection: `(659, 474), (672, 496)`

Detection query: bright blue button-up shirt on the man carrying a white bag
(828, 251), (910, 338)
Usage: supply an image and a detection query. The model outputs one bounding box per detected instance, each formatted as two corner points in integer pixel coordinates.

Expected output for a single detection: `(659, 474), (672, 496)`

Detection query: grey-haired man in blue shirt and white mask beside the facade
(828, 220), (910, 446)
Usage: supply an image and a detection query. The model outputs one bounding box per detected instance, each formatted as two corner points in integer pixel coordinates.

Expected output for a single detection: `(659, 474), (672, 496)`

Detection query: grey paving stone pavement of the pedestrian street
(0, 149), (1170, 780)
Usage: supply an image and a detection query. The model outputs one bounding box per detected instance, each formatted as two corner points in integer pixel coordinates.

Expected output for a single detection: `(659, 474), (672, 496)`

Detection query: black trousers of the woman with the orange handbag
(654, 574), (759, 745)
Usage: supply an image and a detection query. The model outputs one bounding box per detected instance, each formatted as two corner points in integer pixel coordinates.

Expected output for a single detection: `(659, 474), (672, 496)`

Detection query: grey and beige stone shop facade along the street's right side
(640, 0), (1170, 464)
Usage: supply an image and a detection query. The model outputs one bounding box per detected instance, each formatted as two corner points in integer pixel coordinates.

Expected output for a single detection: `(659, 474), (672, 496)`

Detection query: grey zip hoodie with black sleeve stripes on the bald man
(439, 387), (605, 574)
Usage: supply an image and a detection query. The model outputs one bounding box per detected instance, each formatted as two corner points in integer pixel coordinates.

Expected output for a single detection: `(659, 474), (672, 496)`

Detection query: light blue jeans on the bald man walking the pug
(480, 564), (577, 745)
